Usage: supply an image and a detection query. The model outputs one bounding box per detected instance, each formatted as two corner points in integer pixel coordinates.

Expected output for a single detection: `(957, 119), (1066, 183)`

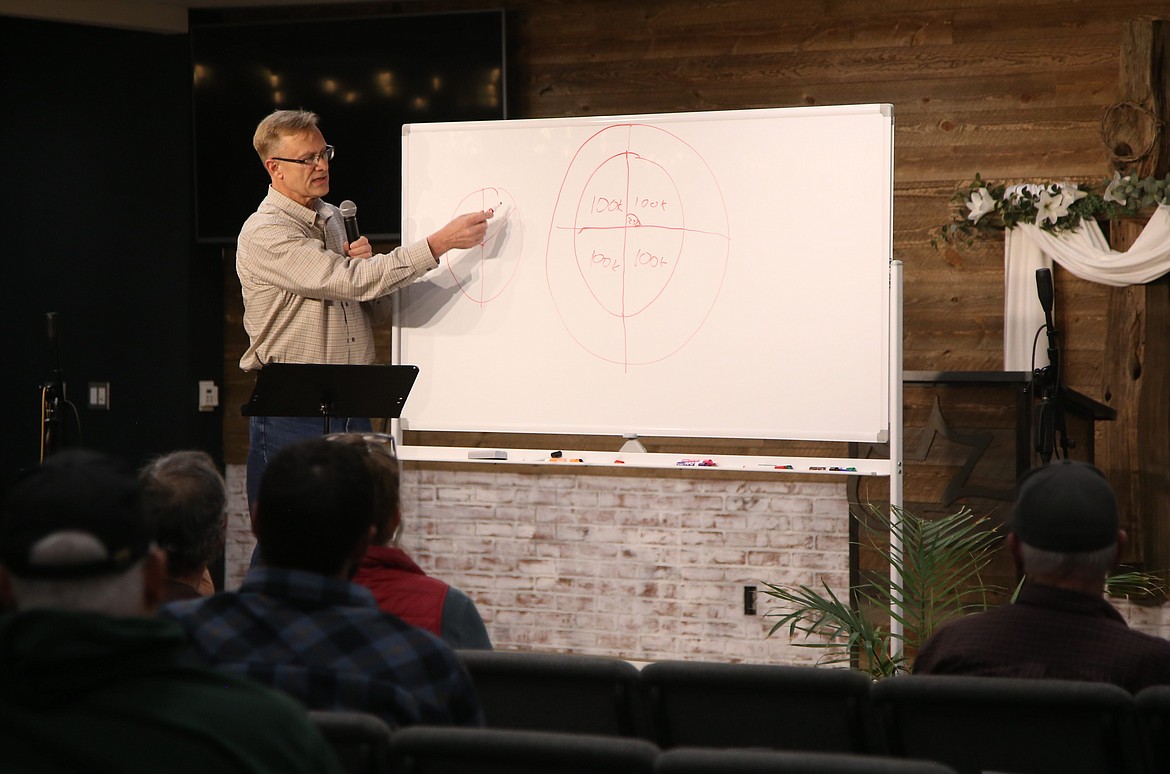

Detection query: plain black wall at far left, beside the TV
(0, 16), (222, 485)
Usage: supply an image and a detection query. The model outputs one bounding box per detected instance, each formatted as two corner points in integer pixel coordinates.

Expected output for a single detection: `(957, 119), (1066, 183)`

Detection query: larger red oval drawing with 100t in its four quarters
(545, 124), (730, 368)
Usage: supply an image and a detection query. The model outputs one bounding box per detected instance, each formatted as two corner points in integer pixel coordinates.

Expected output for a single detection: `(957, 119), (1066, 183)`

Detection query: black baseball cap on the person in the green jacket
(0, 449), (154, 579)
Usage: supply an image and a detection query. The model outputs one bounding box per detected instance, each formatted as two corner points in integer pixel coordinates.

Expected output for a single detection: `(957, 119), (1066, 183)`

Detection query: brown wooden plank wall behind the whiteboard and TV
(223, 0), (1170, 514)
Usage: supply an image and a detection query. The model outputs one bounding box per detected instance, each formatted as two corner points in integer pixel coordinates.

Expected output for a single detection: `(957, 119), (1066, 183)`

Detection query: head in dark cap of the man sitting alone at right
(1010, 459), (1126, 592)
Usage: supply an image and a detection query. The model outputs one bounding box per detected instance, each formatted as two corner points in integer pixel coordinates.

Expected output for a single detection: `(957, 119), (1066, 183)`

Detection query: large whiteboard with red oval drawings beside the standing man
(393, 104), (893, 442)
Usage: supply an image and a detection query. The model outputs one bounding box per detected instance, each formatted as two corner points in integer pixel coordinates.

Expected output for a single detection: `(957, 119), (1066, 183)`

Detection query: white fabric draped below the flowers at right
(1004, 205), (1170, 371)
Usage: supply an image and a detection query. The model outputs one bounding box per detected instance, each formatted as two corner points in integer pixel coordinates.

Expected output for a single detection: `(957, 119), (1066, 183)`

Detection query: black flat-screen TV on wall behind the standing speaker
(191, 11), (507, 243)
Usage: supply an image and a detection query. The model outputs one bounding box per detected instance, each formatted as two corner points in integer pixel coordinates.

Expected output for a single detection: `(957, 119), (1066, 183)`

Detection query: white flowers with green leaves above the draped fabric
(935, 172), (1170, 244)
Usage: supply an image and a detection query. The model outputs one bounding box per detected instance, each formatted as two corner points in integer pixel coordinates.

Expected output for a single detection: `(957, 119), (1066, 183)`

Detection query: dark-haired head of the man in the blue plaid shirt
(253, 438), (376, 578)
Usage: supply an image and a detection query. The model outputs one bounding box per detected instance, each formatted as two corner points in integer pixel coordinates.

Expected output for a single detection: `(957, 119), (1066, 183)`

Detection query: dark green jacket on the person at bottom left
(0, 610), (342, 774)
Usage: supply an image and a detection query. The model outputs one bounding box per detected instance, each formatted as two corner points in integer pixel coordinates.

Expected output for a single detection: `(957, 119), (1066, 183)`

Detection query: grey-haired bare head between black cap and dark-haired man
(138, 450), (227, 591)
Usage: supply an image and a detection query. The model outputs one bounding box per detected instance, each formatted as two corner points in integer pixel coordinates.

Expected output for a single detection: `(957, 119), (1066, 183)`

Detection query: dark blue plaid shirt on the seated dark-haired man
(159, 567), (483, 728)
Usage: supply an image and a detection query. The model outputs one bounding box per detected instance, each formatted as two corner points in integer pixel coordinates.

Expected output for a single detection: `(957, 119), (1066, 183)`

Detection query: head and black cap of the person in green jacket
(0, 449), (166, 616)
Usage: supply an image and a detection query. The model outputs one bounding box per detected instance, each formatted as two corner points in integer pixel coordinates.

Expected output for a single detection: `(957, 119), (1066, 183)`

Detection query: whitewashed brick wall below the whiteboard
(226, 465), (1170, 664)
